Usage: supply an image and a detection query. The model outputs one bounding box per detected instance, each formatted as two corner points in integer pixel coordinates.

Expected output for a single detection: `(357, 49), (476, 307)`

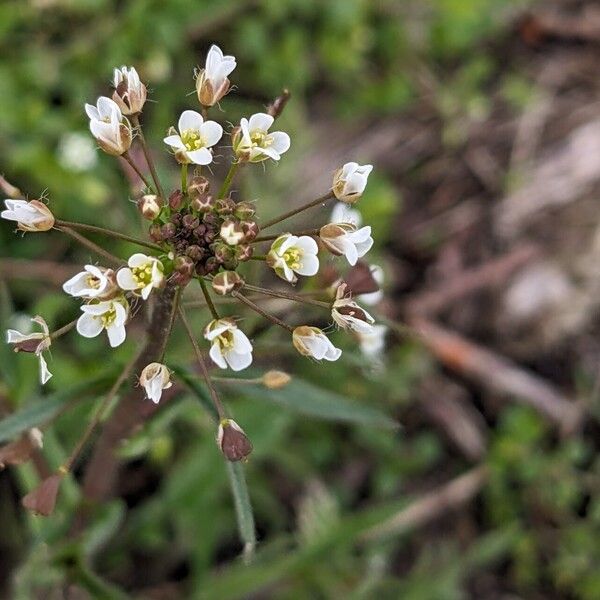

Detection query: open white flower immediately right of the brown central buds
(267, 233), (319, 283)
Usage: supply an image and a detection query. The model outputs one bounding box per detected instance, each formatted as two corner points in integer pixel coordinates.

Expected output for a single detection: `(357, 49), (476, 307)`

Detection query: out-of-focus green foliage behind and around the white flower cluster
(0, 0), (600, 600)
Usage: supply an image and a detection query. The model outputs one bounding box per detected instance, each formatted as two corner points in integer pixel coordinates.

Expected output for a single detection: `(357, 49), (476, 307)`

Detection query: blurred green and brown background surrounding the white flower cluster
(0, 0), (600, 600)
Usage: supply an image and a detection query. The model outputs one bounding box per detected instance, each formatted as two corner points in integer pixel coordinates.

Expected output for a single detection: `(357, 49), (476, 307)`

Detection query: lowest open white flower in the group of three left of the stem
(77, 296), (129, 348)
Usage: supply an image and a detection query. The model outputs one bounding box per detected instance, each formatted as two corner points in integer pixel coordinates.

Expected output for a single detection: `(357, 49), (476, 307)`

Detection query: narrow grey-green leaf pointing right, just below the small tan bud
(240, 378), (398, 429)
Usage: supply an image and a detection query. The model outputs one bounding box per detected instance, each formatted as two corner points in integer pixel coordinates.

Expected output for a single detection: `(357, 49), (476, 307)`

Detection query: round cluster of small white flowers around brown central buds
(0, 46), (383, 460)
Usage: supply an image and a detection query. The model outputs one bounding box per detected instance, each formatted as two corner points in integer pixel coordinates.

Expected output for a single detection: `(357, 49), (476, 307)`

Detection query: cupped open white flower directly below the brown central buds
(204, 319), (252, 371)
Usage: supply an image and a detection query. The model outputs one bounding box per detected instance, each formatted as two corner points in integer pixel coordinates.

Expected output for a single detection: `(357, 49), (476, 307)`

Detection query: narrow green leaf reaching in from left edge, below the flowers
(0, 371), (113, 443)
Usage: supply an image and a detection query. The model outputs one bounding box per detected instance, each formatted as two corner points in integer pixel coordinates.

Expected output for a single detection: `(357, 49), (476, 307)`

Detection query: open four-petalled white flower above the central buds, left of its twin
(164, 110), (223, 165)
